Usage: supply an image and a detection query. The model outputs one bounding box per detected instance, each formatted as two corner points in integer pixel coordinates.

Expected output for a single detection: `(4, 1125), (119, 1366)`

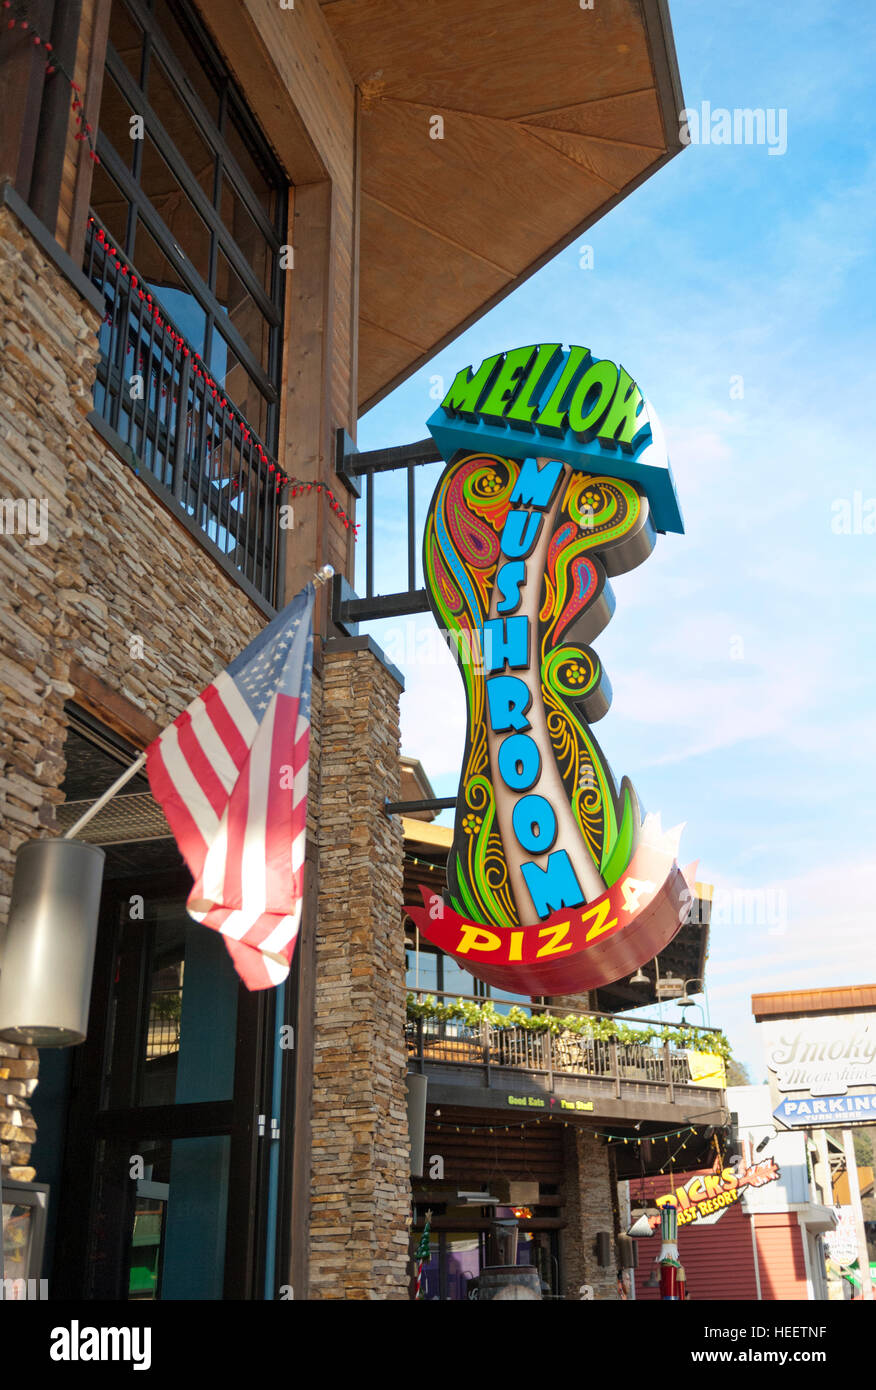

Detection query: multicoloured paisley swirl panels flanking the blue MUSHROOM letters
(424, 455), (647, 927)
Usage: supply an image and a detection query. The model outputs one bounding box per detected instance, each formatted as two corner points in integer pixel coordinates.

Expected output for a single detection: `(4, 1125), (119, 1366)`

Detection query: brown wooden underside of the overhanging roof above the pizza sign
(323, 0), (684, 410)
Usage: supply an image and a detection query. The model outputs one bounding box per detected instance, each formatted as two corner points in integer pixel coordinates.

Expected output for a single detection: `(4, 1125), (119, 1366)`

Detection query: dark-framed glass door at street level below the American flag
(56, 874), (273, 1300)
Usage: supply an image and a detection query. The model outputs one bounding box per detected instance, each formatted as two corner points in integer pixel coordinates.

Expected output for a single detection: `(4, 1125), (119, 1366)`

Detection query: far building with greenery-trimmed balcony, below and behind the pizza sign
(402, 811), (730, 1301)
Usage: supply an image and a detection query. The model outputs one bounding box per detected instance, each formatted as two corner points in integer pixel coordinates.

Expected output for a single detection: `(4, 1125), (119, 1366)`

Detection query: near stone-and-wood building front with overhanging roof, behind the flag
(0, 0), (700, 1300)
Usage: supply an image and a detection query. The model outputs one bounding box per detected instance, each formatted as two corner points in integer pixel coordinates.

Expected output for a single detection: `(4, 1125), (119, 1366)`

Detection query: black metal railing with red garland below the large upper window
(85, 215), (285, 603)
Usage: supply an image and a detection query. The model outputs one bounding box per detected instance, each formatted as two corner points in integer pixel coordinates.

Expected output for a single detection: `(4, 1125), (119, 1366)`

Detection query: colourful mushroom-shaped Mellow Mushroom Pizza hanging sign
(412, 343), (692, 995)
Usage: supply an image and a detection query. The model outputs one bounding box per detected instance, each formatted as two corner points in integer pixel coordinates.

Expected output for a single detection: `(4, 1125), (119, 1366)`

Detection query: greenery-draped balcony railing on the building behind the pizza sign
(406, 990), (719, 1101)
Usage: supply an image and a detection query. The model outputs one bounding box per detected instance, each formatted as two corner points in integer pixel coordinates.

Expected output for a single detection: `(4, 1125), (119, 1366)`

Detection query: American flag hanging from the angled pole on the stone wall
(146, 584), (316, 990)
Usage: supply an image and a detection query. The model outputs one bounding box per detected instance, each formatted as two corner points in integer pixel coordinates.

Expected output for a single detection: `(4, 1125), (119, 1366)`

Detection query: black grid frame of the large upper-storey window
(97, 0), (289, 453)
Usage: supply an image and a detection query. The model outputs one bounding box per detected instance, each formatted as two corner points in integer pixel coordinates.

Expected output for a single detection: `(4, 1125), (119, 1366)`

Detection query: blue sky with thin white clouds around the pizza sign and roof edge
(357, 0), (876, 1080)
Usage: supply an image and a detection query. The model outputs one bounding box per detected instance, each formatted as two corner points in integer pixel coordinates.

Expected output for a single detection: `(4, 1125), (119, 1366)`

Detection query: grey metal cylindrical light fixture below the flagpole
(0, 840), (104, 1047)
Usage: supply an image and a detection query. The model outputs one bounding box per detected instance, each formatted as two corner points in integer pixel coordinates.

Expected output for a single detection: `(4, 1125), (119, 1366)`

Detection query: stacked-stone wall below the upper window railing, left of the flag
(0, 207), (266, 1180)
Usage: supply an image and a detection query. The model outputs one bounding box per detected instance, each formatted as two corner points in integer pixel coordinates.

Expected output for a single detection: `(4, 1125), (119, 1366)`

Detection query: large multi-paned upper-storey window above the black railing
(92, 0), (286, 452)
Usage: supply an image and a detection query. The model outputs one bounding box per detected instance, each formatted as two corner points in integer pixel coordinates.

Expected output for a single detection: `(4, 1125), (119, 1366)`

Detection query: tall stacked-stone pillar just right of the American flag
(309, 639), (410, 1300)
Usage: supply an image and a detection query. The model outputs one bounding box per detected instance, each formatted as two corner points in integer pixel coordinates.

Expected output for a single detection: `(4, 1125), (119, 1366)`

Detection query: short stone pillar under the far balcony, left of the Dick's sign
(560, 1125), (617, 1300)
